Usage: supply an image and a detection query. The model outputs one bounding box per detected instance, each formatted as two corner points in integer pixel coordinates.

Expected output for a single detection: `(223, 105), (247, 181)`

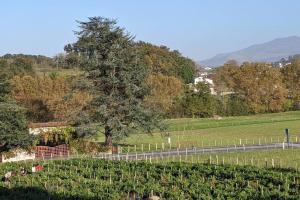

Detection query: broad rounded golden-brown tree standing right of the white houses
(234, 63), (287, 113)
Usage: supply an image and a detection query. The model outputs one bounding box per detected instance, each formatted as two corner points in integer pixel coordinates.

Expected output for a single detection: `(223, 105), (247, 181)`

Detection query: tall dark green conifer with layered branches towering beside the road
(65, 17), (164, 146)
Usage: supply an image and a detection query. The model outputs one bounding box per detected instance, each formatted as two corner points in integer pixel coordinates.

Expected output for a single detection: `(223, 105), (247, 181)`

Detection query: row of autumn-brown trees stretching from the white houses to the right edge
(213, 59), (300, 115)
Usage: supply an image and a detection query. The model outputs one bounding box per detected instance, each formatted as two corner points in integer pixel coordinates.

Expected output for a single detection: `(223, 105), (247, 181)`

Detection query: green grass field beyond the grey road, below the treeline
(97, 111), (300, 152)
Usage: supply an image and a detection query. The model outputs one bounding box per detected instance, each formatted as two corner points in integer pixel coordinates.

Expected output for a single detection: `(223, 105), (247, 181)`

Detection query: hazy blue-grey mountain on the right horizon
(199, 36), (300, 67)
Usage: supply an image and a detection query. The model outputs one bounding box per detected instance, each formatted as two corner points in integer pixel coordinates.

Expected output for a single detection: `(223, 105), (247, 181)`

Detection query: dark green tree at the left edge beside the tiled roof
(0, 102), (34, 152)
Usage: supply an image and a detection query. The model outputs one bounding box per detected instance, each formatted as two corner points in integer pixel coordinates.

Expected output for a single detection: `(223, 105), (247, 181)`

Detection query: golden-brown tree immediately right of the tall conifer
(145, 74), (183, 114)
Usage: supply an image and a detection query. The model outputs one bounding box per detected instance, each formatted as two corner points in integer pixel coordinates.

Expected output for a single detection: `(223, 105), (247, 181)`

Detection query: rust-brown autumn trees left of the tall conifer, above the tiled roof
(11, 75), (91, 122)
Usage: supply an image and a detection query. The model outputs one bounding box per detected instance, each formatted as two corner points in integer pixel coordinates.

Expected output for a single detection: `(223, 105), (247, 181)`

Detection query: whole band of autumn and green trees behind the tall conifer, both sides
(0, 45), (300, 122)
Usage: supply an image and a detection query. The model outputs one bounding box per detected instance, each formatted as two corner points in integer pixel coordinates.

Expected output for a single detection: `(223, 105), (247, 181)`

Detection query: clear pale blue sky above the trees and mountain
(0, 0), (300, 61)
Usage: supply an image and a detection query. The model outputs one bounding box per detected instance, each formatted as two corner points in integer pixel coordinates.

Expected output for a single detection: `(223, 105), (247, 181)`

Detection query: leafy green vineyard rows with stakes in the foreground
(0, 158), (300, 200)
